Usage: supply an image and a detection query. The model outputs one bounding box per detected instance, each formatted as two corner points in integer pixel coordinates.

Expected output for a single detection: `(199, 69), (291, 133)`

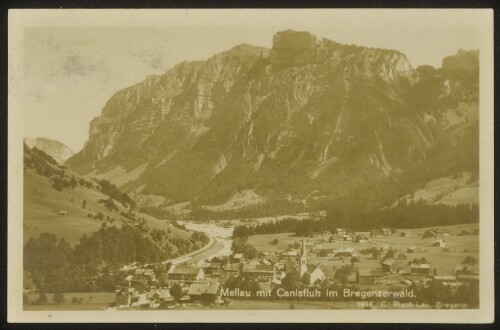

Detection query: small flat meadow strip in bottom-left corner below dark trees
(24, 292), (115, 311)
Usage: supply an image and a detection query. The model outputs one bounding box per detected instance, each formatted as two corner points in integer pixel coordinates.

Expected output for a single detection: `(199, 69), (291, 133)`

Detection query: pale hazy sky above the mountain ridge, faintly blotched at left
(17, 10), (479, 151)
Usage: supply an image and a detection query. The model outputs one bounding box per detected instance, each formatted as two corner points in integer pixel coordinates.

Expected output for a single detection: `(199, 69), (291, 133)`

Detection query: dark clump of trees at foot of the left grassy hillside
(23, 225), (167, 292)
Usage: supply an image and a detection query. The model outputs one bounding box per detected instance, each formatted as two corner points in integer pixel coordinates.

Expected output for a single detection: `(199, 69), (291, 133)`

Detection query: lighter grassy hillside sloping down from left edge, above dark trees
(23, 145), (203, 257)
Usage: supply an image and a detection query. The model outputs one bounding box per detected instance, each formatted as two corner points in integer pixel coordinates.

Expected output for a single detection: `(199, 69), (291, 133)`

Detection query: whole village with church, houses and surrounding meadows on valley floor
(110, 225), (479, 309)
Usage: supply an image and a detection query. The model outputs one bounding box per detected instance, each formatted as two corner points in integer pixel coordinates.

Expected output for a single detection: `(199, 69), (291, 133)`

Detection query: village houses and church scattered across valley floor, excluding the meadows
(112, 229), (479, 308)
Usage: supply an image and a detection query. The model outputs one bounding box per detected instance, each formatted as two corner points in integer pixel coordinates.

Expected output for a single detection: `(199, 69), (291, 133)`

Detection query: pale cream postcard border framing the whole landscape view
(7, 9), (495, 323)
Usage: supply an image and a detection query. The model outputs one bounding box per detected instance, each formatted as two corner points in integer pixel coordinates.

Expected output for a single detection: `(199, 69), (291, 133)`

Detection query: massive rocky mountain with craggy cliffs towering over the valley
(65, 30), (479, 215)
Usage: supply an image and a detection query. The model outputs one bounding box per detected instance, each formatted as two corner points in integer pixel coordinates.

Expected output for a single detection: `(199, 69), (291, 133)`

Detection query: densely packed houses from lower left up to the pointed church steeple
(115, 241), (326, 308)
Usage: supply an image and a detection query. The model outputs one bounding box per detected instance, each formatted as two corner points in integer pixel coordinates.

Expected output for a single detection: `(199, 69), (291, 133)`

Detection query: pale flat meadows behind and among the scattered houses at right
(248, 224), (479, 275)
